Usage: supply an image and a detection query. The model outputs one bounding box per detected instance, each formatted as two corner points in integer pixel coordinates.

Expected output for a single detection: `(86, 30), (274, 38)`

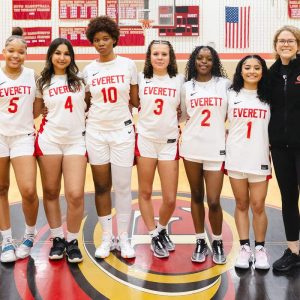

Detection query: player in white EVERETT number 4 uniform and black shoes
(35, 38), (87, 263)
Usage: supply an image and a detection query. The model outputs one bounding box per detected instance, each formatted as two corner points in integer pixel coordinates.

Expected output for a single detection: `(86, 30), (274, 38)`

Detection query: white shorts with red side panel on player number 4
(35, 134), (86, 156)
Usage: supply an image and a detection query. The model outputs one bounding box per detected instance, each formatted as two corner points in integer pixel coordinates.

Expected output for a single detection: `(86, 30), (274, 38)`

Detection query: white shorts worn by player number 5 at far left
(0, 132), (35, 158)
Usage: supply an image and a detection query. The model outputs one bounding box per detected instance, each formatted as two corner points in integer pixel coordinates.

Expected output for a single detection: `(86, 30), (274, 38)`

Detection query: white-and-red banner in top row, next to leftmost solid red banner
(58, 0), (98, 19)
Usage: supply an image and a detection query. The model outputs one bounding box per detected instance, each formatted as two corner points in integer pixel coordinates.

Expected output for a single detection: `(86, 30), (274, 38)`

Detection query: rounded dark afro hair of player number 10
(86, 16), (120, 47)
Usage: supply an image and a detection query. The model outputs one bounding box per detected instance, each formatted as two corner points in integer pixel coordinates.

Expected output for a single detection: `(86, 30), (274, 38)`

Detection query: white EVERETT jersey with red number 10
(83, 56), (137, 130)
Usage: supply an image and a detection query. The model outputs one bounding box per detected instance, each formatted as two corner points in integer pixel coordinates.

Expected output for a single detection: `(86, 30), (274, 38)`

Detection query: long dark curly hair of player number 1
(230, 54), (270, 103)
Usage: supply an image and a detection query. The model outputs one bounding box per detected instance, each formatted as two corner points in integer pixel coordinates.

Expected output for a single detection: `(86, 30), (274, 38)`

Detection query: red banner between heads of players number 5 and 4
(23, 27), (52, 47)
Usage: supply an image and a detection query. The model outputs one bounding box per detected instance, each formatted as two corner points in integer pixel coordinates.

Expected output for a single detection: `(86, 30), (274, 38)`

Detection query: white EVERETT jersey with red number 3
(137, 73), (184, 142)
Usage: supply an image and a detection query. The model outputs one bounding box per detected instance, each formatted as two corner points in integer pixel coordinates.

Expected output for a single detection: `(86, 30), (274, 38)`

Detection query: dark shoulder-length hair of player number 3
(144, 40), (178, 78)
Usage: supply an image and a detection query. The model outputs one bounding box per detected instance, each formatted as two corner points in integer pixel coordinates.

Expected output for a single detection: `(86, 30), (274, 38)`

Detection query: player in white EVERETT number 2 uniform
(180, 46), (230, 264)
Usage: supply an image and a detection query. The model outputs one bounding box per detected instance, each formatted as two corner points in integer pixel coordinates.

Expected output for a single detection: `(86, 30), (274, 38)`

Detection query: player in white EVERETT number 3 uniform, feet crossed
(135, 40), (184, 258)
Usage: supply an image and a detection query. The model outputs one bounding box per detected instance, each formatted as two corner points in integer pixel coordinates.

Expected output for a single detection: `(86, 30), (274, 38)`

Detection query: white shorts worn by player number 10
(86, 126), (135, 167)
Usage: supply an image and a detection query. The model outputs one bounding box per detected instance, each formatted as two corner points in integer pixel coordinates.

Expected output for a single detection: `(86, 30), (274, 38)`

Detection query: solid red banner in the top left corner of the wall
(12, 0), (51, 20)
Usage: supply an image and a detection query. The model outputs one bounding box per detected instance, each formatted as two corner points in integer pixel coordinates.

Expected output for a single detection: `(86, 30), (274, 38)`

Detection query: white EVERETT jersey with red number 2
(180, 77), (230, 161)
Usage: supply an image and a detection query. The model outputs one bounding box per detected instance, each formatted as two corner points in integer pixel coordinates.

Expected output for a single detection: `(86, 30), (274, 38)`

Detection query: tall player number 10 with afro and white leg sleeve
(84, 16), (138, 258)
